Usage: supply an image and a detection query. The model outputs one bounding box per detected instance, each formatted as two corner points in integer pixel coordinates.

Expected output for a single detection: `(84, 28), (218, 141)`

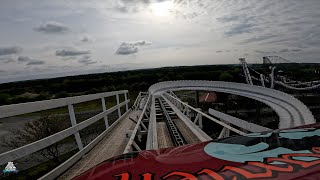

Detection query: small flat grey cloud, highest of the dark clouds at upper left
(34, 22), (69, 34)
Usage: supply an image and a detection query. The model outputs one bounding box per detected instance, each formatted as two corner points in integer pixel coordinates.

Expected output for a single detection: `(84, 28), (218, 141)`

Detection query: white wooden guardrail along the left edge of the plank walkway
(0, 90), (130, 174)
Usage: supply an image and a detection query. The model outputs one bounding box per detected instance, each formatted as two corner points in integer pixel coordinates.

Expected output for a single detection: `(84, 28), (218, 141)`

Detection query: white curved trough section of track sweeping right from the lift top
(149, 81), (315, 128)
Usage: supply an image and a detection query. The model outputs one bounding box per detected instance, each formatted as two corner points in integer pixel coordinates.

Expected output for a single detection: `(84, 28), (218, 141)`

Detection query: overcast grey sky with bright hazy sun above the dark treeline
(0, 0), (320, 83)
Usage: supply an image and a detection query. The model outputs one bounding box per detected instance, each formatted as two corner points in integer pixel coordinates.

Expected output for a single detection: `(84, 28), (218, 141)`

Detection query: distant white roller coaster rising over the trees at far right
(239, 56), (320, 91)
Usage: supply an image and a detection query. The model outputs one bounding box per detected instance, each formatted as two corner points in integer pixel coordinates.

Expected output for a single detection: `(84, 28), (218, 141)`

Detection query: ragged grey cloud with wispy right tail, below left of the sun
(116, 41), (151, 55)
